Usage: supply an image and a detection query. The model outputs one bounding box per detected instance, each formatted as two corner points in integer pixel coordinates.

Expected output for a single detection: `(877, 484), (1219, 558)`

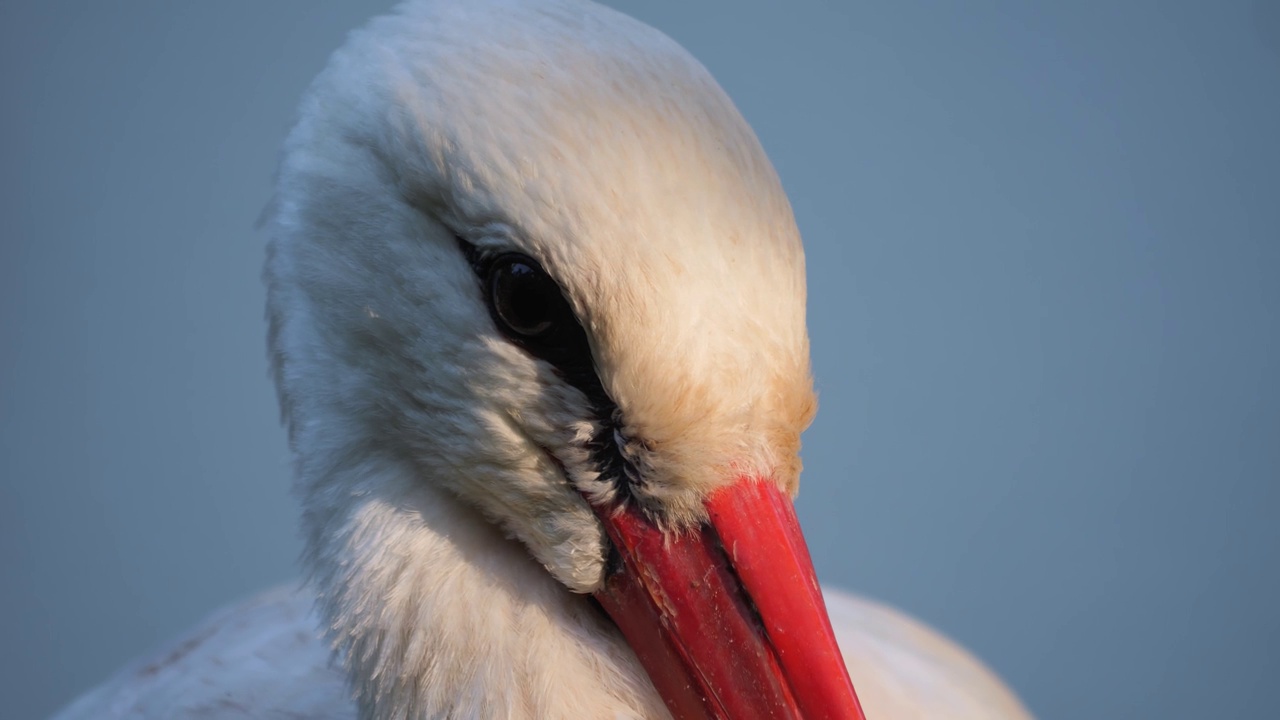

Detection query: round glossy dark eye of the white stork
(488, 252), (575, 342)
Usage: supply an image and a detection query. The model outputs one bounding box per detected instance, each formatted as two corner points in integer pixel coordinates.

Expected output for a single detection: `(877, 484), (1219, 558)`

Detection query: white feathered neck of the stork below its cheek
(303, 453), (667, 720)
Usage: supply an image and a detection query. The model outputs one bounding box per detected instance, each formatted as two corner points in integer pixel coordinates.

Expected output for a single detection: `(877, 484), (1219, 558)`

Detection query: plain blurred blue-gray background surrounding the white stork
(0, 0), (1280, 719)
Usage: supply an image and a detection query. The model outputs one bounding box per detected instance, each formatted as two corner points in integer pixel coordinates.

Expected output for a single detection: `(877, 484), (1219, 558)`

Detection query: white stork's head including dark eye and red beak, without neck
(266, 1), (856, 716)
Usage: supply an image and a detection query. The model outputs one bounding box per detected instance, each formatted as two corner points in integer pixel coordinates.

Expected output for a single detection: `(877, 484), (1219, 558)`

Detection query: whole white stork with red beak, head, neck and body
(58, 0), (1027, 720)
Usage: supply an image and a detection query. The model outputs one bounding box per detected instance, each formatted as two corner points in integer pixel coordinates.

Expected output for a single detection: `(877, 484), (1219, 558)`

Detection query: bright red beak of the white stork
(595, 478), (864, 720)
